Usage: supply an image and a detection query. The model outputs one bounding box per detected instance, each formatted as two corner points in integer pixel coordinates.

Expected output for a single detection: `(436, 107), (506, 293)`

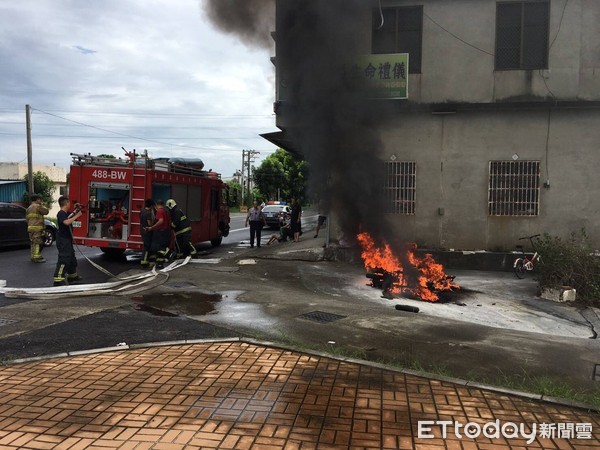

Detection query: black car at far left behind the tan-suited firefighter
(0, 202), (58, 247)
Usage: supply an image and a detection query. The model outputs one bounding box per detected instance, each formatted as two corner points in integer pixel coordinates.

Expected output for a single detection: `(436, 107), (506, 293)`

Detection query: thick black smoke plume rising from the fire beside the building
(208, 0), (392, 241)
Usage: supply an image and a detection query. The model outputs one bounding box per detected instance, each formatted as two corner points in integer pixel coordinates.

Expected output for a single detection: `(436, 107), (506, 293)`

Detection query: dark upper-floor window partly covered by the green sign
(371, 6), (423, 73)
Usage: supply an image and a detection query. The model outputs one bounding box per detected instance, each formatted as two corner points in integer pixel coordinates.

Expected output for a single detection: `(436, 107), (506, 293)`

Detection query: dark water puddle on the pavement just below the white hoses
(132, 292), (221, 317)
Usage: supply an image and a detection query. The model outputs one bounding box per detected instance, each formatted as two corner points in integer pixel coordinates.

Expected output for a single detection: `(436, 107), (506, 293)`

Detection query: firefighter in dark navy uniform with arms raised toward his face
(54, 196), (83, 286)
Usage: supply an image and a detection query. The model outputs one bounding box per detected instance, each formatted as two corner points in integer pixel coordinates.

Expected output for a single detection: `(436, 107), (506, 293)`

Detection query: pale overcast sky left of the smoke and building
(0, 0), (276, 177)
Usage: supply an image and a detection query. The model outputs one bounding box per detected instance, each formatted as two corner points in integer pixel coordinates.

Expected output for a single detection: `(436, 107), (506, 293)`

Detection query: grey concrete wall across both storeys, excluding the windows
(277, 0), (600, 251)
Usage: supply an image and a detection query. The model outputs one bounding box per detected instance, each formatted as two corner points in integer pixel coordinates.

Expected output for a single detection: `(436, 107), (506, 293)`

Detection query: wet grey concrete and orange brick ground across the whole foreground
(0, 233), (600, 449)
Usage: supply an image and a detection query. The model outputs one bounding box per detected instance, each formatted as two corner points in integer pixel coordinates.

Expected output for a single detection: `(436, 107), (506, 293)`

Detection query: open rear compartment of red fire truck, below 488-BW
(87, 181), (130, 240)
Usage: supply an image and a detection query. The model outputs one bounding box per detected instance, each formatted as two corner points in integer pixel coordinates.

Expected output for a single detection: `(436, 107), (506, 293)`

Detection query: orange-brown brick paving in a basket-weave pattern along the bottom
(0, 342), (600, 450)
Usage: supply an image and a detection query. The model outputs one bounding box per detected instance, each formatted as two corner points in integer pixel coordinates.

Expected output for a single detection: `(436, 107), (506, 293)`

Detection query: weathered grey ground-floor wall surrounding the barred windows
(382, 109), (600, 250)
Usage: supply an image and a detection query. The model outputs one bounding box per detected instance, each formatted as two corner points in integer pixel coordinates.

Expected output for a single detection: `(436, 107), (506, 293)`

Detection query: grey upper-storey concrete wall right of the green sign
(404, 0), (600, 103)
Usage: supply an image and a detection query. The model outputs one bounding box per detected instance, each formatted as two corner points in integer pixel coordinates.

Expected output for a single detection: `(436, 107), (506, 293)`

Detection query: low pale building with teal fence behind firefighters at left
(0, 163), (67, 216)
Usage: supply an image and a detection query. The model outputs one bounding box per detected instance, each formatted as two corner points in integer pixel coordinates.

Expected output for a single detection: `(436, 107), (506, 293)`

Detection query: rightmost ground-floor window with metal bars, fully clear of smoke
(488, 161), (540, 216)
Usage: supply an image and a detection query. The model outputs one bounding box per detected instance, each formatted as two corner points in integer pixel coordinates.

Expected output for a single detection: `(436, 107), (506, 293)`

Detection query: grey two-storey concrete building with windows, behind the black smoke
(265, 0), (600, 250)
